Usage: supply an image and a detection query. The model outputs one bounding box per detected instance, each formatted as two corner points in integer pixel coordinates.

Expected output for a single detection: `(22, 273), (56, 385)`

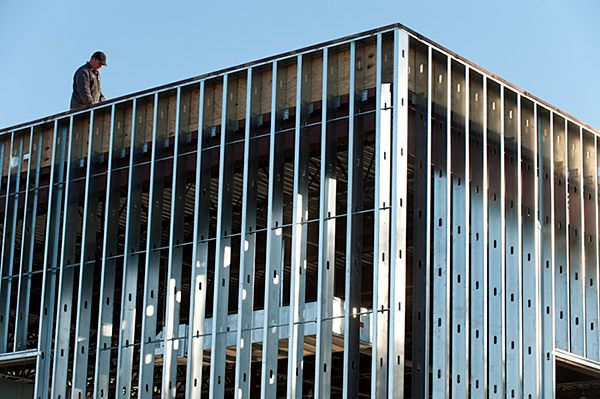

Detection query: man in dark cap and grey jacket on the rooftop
(71, 51), (106, 109)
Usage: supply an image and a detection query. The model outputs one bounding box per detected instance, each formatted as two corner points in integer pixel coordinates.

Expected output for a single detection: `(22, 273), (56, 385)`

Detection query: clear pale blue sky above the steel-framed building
(0, 0), (600, 129)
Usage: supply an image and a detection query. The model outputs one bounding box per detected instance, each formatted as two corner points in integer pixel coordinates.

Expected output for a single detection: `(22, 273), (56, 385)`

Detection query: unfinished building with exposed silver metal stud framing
(0, 24), (600, 399)
